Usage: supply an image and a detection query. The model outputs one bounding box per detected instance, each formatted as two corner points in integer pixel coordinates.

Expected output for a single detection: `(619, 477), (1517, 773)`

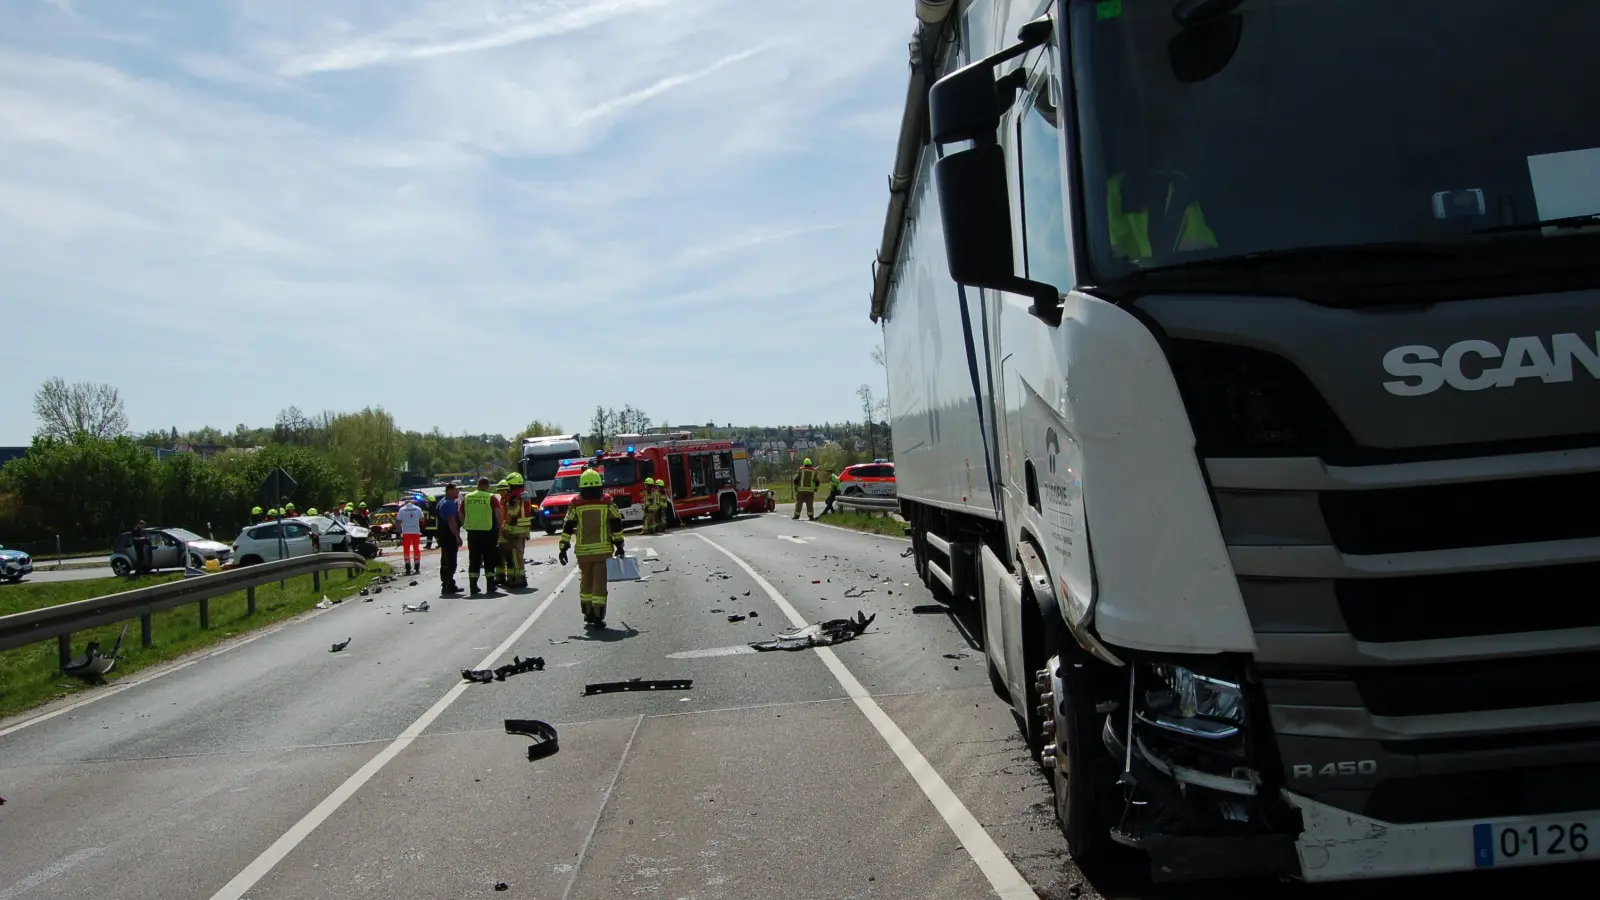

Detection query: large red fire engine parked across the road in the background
(597, 431), (758, 525)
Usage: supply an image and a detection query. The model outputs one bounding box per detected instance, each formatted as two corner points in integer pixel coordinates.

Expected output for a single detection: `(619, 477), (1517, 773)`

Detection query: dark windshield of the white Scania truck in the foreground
(1069, 0), (1600, 282)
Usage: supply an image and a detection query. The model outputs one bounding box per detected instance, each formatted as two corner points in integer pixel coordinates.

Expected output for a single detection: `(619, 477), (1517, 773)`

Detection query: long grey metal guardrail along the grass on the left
(0, 552), (366, 666)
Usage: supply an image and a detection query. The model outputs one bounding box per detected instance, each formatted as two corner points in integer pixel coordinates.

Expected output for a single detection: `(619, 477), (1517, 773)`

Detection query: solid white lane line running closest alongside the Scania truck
(694, 535), (1038, 900)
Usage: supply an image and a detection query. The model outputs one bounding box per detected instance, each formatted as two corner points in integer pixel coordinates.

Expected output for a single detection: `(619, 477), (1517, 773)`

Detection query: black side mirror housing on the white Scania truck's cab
(928, 18), (1061, 325)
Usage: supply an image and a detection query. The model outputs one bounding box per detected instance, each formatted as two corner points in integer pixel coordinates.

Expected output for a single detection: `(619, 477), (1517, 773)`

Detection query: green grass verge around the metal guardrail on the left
(0, 562), (389, 716)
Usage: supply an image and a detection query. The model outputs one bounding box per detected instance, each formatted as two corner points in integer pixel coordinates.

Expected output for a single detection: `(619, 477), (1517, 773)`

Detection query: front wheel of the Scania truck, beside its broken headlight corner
(1038, 657), (1112, 865)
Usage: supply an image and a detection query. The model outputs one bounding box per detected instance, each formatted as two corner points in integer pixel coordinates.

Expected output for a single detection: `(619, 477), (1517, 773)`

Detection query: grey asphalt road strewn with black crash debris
(0, 516), (1594, 900)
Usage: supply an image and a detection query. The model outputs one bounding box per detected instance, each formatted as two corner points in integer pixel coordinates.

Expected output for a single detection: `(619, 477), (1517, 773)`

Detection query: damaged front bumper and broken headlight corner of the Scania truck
(1101, 663), (1600, 882)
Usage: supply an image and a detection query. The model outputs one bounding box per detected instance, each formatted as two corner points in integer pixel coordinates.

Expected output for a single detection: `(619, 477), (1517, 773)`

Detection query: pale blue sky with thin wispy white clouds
(0, 0), (915, 444)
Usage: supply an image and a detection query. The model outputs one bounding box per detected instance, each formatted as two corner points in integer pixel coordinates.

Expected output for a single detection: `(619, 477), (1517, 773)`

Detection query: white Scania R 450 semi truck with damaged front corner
(872, 0), (1600, 881)
